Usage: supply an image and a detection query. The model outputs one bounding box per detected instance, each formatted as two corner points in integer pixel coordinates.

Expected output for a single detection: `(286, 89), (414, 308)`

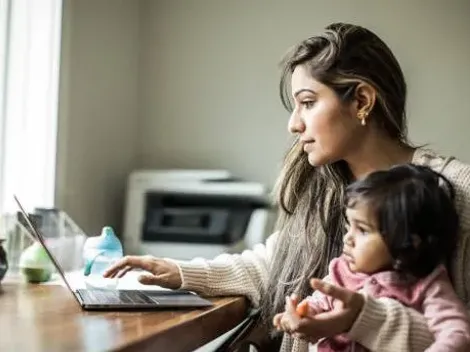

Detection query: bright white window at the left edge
(0, 0), (62, 213)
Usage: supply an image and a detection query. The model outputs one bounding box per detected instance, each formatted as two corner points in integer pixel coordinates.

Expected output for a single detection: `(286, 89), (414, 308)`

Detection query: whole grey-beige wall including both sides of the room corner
(57, 0), (470, 233)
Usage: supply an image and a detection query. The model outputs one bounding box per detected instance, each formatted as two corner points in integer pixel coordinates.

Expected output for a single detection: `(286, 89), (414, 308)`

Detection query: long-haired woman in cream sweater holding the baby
(105, 23), (470, 351)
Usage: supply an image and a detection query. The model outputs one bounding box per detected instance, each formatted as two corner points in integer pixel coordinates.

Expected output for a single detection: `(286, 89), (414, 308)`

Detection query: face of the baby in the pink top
(343, 202), (393, 274)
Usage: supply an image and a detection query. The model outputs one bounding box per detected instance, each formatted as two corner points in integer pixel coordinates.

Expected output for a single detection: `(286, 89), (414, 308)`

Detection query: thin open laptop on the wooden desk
(14, 196), (213, 310)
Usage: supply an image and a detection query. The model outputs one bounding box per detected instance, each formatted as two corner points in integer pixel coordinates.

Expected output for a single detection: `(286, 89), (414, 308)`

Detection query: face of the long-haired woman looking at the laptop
(288, 65), (365, 166)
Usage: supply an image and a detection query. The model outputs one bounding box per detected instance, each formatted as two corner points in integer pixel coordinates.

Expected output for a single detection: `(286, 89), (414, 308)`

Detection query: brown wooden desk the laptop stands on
(0, 282), (247, 352)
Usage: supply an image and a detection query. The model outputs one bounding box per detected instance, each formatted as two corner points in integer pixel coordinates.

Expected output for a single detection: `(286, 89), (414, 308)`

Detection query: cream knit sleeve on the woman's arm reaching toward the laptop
(165, 233), (278, 306)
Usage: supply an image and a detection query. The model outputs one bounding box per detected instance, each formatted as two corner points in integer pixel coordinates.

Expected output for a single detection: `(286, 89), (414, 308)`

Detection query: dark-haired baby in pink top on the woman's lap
(274, 164), (470, 352)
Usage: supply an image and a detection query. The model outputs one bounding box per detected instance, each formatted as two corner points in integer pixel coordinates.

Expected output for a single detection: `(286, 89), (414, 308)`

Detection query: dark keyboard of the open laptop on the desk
(77, 289), (156, 304)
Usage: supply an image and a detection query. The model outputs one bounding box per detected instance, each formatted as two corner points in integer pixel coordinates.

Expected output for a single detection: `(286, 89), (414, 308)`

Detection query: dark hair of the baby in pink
(346, 164), (459, 278)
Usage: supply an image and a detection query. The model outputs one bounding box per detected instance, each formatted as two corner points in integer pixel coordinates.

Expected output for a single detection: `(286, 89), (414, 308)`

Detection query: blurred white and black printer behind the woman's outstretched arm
(123, 170), (273, 260)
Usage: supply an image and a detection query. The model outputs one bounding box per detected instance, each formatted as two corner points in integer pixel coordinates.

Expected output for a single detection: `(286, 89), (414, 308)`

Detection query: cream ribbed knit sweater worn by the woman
(173, 148), (470, 352)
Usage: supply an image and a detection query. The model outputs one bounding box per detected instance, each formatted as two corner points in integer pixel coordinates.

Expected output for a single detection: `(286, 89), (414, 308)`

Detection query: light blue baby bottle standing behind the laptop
(83, 226), (122, 289)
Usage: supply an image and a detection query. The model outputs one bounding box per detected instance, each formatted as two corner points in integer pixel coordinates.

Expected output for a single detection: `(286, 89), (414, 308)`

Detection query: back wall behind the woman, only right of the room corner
(139, 0), (470, 187)
